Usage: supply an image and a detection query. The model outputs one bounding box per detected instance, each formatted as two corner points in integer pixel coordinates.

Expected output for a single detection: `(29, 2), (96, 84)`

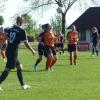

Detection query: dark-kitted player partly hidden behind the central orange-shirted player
(34, 25), (46, 71)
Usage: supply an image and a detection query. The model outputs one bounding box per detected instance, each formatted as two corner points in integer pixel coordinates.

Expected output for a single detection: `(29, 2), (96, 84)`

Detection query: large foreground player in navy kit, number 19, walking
(0, 16), (35, 90)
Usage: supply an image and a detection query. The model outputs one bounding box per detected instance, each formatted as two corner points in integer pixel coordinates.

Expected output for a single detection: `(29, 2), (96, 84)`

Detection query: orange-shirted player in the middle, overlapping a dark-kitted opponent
(43, 24), (57, 71)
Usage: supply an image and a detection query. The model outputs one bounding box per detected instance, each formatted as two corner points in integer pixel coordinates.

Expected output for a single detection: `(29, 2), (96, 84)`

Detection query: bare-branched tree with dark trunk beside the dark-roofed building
(24, 0), (99, 34)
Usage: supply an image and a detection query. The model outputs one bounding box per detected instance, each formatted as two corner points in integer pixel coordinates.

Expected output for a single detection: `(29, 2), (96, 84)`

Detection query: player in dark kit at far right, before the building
(91, 27), (99, 56)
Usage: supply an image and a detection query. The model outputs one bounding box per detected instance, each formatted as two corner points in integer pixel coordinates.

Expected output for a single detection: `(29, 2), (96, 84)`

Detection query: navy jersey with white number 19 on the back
(7, 26), (27, 50)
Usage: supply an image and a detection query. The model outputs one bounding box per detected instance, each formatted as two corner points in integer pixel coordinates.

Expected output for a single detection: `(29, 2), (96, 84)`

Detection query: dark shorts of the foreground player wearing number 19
(6, 51), (21, 69)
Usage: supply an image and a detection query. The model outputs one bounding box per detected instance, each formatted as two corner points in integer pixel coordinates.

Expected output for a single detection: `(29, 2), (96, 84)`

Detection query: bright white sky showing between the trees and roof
(1, 0), (81, 27)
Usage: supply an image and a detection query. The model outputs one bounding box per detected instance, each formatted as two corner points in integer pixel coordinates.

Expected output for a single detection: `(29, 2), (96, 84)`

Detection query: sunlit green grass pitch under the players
(0, 49), (100, 100)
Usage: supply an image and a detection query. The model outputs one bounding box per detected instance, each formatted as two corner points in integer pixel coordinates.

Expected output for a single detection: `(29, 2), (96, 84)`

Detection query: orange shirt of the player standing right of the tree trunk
(67, 31), (78, 44)
